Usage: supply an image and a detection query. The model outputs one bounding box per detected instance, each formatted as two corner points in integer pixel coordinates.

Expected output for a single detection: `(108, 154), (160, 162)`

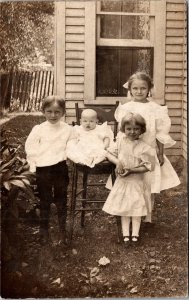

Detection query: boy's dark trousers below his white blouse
(36, 161), (69, 238)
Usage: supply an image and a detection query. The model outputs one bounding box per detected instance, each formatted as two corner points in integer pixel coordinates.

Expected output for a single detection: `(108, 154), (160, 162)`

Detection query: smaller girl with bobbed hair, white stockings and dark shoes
(103, 113), (154, 245)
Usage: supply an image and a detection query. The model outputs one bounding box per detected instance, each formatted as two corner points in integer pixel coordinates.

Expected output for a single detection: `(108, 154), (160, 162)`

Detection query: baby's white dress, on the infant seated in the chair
(67, 122), (113, 168)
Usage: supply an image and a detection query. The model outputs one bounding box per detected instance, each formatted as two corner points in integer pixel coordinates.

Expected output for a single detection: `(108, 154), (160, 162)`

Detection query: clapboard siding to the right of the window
(165, 0), (185, 155)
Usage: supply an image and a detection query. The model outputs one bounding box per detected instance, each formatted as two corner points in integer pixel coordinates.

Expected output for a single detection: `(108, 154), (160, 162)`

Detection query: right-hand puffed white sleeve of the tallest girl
(155, 105), (176, 148)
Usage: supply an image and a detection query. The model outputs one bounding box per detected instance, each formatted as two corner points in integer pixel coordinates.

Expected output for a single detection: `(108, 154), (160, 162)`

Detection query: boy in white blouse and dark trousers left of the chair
(25, 96), (72, 243)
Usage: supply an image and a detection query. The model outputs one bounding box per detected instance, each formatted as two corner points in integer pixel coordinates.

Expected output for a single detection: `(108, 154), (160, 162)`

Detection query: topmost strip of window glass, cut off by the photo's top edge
(101, 0), (150, 13)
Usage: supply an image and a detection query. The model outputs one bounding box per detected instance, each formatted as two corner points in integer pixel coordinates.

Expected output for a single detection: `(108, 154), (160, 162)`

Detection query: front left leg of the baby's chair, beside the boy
(69, 164), (78, 243)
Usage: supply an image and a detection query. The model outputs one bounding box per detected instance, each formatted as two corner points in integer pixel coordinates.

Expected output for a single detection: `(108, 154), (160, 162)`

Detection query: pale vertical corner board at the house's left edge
(55, 1), (66, 99)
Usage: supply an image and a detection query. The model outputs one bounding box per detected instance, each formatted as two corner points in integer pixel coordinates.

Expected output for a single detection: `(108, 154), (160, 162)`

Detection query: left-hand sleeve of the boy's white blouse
(25, 125), (40, 172)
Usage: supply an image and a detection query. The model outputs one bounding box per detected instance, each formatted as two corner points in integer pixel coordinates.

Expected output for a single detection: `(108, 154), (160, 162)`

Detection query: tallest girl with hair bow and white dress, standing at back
(115, 72), (180, 222)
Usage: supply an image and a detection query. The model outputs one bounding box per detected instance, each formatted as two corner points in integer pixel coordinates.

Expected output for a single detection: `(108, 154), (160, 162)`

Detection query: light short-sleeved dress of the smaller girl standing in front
(103, 135), (154, 216)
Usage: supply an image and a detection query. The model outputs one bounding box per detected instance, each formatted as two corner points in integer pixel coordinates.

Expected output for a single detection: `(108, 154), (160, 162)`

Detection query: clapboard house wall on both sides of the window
(56, 0), (187, 158)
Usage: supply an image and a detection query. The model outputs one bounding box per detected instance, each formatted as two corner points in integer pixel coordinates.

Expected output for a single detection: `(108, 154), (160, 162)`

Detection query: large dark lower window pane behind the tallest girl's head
(96, 47), (153, 97)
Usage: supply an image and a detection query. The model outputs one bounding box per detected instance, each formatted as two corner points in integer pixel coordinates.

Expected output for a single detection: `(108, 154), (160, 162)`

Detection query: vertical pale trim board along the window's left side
(84, 1), (96, 100)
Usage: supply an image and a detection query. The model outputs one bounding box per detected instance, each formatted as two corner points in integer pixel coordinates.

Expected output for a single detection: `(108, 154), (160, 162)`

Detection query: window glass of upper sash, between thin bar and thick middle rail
(100, 15), (150, 39)
